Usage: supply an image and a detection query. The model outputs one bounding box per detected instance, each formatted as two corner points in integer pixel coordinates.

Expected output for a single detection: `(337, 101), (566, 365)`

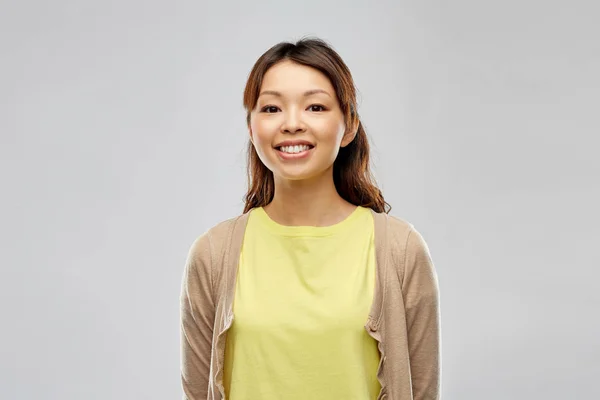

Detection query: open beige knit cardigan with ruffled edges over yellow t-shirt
(180, 210), (441, 400)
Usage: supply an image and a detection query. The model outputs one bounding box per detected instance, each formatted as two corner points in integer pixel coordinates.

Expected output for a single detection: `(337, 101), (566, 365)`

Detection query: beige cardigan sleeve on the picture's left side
(180, 233), (215, 400)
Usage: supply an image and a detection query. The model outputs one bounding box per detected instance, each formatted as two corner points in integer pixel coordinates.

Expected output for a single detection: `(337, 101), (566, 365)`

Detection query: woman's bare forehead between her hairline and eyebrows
(261, 60), (335, 95)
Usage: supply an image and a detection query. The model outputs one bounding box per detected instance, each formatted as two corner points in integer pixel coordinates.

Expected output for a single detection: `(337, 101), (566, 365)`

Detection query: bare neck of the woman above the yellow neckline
(263, 169), (356, 226)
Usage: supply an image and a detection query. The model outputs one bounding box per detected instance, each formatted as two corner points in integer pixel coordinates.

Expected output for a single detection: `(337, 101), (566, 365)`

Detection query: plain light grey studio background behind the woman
(0, 0), (600, 400)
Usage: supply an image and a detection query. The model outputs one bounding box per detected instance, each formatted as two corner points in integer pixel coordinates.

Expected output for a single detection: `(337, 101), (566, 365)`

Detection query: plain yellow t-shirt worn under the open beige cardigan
(223, 207), (380, 400)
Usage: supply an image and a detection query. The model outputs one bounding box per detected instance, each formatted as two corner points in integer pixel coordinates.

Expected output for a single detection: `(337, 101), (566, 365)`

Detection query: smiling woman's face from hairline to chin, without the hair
(250, 60), (354, 180)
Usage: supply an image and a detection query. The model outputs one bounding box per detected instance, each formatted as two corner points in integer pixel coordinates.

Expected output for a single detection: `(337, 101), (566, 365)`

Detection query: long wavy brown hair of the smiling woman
(243, 38), (392, 213)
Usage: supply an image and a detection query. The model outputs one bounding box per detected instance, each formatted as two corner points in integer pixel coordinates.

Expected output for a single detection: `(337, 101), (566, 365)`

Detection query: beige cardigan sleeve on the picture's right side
(402, 227), (441, 400)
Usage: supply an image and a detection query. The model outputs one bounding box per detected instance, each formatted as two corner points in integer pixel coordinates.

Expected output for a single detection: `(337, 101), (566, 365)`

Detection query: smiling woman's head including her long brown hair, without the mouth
(244, 39), (391, 212)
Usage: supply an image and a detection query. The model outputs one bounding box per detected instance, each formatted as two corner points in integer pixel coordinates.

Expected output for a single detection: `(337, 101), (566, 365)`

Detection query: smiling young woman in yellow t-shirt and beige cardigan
(181, 39), (441, 400)
